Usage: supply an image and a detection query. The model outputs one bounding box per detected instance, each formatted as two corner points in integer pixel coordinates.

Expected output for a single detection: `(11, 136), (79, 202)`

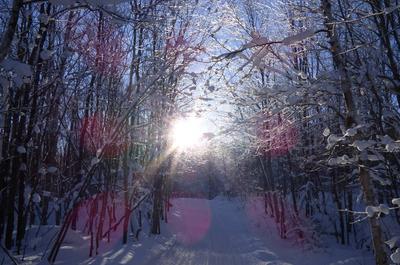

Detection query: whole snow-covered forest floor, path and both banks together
(5, 197), (373, 265)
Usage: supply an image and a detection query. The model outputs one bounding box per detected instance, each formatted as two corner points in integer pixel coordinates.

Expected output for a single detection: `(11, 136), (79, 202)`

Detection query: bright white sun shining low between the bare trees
(170, 116), (205, 150)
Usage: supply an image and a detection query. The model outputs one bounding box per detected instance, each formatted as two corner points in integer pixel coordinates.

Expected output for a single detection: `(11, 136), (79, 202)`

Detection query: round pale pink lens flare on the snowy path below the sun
(167, 199), (211, 245)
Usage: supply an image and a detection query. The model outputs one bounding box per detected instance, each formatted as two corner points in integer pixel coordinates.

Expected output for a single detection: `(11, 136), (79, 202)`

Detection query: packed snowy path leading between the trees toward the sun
(134, 200), (285, 265)
